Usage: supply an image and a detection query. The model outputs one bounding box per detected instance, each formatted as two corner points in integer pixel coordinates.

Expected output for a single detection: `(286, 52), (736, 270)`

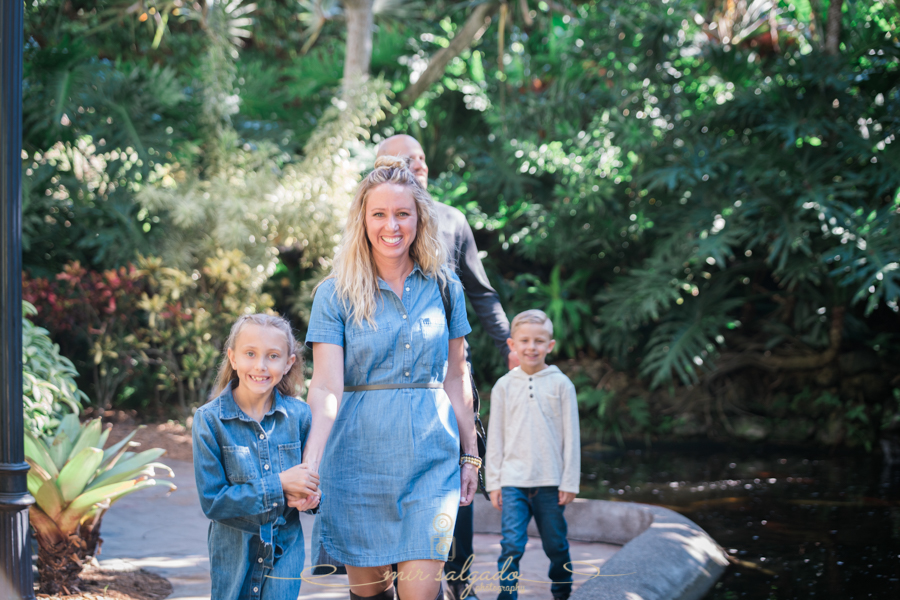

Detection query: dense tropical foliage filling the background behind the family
(23, 0), (900, 448)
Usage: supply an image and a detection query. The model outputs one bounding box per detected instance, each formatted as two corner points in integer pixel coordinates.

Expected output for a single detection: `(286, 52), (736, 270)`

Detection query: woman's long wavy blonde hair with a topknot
(324, 156), (447, 328)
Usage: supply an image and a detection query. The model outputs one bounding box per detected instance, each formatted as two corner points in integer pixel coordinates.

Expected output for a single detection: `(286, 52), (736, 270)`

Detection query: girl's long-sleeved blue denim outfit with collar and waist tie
(192, 386), (312, 600)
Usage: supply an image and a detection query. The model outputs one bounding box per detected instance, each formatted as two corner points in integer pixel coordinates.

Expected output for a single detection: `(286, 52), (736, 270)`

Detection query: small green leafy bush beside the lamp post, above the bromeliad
(22, 302), (88, 435)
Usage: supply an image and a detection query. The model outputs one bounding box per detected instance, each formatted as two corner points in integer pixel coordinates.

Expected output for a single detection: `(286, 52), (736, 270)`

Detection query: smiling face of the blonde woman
(366, 183), (419, 263)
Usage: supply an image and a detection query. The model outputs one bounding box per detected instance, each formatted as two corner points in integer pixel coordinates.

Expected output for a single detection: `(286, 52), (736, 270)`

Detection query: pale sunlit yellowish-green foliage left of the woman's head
(137, 81), (386, 275)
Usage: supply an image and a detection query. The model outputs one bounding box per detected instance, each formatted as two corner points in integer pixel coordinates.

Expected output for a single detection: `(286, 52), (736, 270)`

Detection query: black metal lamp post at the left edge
(0, 0), (35, 599)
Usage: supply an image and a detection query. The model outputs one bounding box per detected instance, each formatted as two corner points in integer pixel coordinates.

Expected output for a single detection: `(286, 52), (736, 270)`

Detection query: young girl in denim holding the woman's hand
(192, 314), (319, 600)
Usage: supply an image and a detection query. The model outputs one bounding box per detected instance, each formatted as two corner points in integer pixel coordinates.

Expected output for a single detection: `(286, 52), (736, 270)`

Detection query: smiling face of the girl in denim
(228, 323), (297, 399)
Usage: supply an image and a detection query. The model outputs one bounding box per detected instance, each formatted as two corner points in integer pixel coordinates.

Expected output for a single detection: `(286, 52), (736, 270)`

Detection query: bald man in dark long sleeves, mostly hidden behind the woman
(377, 135), (519, 600)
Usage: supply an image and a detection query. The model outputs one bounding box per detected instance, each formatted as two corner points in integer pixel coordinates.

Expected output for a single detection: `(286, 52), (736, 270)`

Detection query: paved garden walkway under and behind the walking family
(99, 460), (618, 600)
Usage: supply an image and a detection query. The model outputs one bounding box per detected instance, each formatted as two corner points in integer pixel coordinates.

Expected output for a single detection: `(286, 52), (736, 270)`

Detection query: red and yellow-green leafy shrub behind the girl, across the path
(23, 250), (272, 415)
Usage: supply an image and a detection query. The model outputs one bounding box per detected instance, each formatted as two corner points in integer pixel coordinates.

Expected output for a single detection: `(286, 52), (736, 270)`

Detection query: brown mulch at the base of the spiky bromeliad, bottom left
(37, 567), (172, 600)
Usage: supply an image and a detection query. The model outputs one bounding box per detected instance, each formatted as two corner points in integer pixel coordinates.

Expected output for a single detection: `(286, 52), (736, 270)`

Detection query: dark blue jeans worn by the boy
(497, 487), (572, 600)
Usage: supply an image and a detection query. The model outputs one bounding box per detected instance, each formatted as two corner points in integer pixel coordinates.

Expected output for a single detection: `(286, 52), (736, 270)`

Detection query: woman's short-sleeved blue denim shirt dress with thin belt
(306, 265), (471, 567)
